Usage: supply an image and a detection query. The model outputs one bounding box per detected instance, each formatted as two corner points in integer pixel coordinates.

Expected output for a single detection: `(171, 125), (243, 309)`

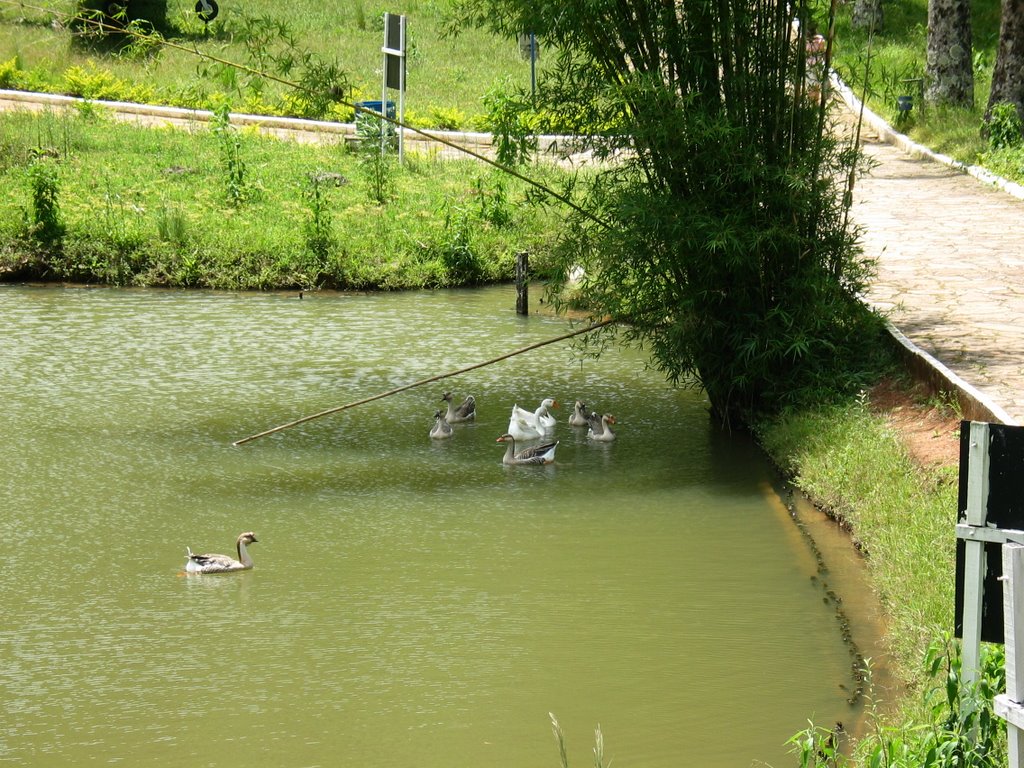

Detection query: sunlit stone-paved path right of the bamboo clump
(853, 96), (1024, 424)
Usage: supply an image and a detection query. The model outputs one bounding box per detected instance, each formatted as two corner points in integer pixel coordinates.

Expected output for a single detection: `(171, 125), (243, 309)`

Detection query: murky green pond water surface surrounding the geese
(0, 287), (870, 768)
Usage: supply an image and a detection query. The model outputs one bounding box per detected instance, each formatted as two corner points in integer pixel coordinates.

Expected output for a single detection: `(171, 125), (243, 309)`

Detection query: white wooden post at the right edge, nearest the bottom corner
(994, 542), (1024, 768)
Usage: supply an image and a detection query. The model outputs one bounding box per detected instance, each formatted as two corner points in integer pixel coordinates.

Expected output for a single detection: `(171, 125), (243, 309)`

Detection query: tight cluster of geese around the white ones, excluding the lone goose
(430, 392), (615, 465)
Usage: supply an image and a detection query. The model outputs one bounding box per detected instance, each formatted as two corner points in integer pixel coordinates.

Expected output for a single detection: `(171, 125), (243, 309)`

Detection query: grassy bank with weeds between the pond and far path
(0, 106), (557, 289)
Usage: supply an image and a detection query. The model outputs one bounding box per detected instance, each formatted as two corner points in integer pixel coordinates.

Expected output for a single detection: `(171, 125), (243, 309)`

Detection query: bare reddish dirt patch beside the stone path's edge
(868, 379), (961, 468)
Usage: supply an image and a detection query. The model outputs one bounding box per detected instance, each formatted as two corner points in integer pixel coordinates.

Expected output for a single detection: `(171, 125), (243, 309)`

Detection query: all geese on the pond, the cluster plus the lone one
(185, 392), (615, 573)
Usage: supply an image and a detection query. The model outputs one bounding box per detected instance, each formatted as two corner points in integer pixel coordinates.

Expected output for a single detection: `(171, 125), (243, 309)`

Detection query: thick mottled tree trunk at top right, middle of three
(925, 0), (974, 108)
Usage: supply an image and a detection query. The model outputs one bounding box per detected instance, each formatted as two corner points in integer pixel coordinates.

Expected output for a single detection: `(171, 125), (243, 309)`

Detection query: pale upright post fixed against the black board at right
(961, 422), (989, 684)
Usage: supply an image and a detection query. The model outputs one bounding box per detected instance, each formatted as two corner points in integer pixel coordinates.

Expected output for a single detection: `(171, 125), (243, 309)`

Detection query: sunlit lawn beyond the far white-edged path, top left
(0, 0), (544, 128)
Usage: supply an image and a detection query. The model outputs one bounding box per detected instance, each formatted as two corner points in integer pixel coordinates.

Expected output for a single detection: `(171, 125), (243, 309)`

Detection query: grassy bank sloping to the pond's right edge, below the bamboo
(759, 393), (1006, 768)
